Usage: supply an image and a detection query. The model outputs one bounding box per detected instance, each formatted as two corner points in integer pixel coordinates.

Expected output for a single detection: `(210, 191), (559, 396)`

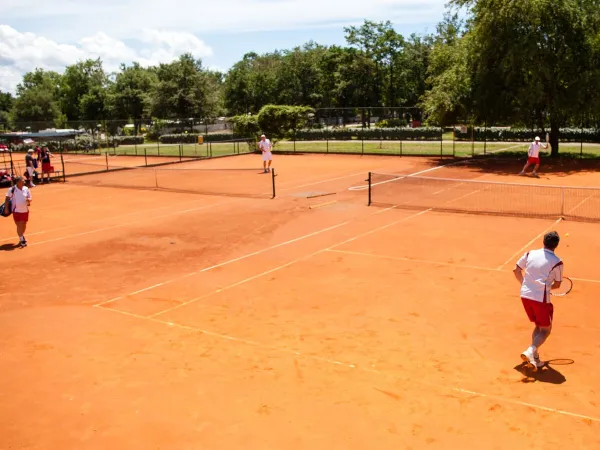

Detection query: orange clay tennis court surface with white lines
(0, 155), (600, 450)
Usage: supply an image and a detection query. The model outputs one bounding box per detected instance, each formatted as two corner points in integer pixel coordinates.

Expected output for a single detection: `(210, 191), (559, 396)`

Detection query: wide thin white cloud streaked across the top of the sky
(2, 0), (446, 41)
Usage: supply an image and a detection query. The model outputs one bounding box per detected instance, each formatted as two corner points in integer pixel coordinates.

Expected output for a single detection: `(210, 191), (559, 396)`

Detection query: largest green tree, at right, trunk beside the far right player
(453, 0), (600, 156)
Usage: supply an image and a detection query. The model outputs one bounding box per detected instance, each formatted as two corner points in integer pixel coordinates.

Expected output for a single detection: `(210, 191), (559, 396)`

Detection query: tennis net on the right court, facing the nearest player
(368, 172), (600, 222)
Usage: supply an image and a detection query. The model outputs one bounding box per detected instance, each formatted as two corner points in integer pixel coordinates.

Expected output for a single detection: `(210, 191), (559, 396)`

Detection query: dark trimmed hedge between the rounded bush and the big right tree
(291, 127), (442, 141)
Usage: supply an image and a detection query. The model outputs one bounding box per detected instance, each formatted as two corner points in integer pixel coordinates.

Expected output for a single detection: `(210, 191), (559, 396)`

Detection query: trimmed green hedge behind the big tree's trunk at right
(455, 127), (600, 143)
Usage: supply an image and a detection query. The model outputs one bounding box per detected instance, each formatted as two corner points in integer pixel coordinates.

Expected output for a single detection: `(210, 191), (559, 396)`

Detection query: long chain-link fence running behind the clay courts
(0, 108), (600, 171)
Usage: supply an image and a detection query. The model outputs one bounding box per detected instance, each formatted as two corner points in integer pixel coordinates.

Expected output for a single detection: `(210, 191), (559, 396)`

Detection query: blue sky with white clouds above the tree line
(0, 0), (446, 92)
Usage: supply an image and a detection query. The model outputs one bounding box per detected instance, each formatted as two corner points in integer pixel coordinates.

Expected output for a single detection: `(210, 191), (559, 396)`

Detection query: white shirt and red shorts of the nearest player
(517, 248), (563, 328)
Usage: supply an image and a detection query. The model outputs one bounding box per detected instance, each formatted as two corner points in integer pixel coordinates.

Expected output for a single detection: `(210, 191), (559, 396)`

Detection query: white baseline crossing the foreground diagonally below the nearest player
(94, 300), (600, 422)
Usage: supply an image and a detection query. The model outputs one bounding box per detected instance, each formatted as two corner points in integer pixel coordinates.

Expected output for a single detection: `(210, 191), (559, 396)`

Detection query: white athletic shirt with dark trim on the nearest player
(517, 248), (563, 303)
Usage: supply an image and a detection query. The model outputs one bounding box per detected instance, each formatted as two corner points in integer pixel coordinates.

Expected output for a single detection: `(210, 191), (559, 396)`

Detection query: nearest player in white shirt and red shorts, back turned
(514, 231), (563, 372)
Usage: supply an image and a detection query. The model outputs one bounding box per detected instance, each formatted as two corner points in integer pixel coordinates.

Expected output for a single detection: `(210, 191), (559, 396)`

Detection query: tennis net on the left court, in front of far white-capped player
(67, 163), (275, 198)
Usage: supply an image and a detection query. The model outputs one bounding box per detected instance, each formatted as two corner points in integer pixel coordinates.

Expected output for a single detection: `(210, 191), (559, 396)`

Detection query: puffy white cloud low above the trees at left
(0, 25), (212, 92)
